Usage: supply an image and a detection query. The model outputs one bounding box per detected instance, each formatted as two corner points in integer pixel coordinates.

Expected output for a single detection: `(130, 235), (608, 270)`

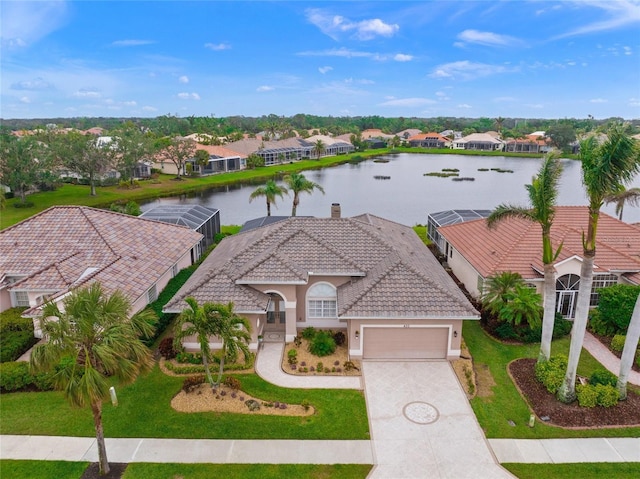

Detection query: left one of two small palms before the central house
(174, 297), (218, 387)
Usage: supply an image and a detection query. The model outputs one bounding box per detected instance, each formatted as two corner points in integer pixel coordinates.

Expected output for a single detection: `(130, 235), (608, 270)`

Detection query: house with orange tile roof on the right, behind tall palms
(430, 206), (640, 318)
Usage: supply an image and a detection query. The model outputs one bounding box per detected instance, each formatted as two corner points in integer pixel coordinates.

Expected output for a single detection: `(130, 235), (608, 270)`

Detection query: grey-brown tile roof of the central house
(165, 214), (478, 318)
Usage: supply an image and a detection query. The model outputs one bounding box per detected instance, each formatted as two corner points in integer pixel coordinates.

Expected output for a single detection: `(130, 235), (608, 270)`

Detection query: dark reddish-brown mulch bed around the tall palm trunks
(509, 358), (640, 428)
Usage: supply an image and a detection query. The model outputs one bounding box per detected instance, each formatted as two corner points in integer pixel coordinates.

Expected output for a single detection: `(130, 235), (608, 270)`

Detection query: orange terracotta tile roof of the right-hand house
(438, 206), (640, 279)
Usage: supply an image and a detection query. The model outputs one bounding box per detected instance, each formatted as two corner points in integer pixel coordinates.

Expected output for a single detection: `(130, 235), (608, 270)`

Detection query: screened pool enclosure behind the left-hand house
(139, 205), (220, 251)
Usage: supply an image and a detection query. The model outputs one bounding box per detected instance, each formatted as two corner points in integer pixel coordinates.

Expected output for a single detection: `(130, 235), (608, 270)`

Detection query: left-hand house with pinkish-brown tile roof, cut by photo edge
(0, 206), (202, 337)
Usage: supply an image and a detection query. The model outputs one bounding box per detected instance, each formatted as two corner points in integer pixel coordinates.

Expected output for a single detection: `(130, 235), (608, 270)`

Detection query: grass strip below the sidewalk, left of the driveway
(123, 463), (372, 479)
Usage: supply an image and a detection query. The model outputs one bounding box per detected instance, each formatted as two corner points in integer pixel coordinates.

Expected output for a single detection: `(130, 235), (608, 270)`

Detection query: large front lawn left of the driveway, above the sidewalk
(0, 367), (369, 439)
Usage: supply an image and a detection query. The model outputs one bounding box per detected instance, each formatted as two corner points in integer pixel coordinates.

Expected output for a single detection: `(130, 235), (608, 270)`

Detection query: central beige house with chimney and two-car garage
(164, 205), (479, 359)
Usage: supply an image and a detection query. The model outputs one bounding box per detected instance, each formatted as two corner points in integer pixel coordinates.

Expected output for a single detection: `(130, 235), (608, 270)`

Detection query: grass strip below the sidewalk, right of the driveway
(502, 462), (640, 479)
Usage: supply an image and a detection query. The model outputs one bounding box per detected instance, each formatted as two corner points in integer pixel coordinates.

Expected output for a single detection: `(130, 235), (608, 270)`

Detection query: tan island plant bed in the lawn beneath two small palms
(171, 383), (315, 416)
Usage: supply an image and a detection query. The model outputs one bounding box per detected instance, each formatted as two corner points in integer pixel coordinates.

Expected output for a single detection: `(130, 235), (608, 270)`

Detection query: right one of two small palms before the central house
(209, 303), (251, 385)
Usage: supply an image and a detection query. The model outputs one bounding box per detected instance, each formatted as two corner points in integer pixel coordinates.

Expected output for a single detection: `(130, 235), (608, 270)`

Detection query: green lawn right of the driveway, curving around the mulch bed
(462, 321), (640, 439)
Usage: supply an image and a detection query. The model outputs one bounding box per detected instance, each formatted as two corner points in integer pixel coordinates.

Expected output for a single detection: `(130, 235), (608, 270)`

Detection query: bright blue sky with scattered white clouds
(0, 0), (640, 119)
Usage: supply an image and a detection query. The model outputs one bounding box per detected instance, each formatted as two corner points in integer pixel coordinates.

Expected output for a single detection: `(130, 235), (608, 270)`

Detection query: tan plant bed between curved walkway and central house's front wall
(282, 339), (362, 376)
